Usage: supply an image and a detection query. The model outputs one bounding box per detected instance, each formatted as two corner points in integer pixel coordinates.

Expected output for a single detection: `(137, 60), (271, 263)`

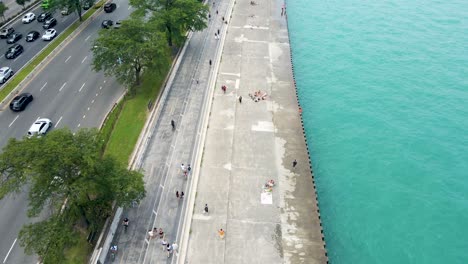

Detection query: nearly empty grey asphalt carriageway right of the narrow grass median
(0, 0), (131, 263)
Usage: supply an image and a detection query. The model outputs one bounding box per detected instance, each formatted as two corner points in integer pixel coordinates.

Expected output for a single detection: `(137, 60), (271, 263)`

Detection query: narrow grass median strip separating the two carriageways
(0, 4), (102, 101)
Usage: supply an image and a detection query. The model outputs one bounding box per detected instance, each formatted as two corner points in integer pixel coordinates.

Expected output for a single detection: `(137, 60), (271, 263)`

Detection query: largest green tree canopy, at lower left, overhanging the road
(0, 129), (145, 263)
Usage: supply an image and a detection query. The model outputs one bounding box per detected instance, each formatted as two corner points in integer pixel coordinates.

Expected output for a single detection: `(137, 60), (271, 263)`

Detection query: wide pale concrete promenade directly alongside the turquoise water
(177, 0), (328, 264)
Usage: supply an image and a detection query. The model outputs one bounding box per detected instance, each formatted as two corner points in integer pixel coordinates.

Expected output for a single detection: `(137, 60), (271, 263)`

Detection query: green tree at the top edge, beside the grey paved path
(130, 0), (209, 46)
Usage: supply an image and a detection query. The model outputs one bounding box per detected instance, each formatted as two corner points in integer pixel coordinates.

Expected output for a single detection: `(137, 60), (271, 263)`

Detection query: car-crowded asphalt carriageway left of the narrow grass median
(0, 7), (78, 82)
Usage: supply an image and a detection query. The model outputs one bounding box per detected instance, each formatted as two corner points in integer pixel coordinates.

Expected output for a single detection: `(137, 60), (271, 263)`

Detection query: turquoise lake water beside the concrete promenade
(287, 0), (468, 264)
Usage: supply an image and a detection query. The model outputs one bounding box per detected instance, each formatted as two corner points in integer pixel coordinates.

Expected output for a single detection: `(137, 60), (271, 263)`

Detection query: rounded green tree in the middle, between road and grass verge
(91, 17), (169, 88)
